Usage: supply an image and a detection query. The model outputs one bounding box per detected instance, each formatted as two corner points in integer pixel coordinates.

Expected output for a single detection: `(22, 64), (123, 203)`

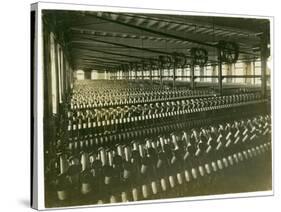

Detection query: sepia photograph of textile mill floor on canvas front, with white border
(31, 2), (273, 208)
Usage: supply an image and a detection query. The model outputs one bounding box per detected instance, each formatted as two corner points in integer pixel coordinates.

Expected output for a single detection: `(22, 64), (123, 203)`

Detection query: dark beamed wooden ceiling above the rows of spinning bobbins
(43, 10), (269, 70)
